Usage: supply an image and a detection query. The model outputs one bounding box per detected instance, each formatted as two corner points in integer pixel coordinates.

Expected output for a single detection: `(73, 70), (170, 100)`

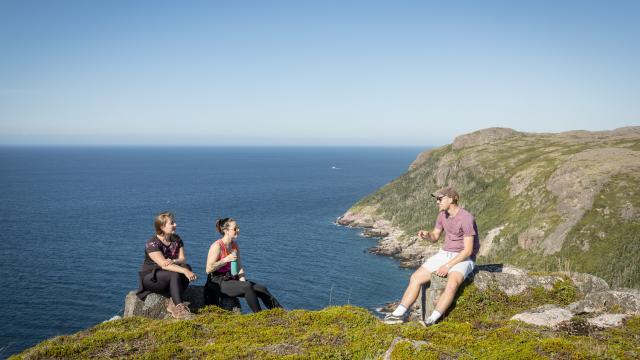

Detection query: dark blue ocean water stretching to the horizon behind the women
(0, 147), (423, 358)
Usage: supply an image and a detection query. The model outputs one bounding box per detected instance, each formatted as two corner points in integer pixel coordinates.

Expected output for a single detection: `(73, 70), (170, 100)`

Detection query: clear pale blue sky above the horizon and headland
(0, 0), (640, 146)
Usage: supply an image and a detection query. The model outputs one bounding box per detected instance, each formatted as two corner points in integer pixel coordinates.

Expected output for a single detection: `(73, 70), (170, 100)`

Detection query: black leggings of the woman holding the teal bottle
(205, 276), (282, 312)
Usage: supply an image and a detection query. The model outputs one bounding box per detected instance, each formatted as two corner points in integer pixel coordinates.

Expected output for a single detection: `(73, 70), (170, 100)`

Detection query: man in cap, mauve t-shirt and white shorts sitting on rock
(383, 187), (480, 326)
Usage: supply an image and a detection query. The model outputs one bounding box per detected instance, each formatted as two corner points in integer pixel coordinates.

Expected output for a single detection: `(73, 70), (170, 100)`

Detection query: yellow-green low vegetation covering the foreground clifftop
(15, 281), (640, 359)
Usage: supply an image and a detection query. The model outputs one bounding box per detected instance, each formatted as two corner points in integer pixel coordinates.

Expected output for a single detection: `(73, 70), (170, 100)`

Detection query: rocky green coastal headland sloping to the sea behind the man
(338, 127), (640, 287)
